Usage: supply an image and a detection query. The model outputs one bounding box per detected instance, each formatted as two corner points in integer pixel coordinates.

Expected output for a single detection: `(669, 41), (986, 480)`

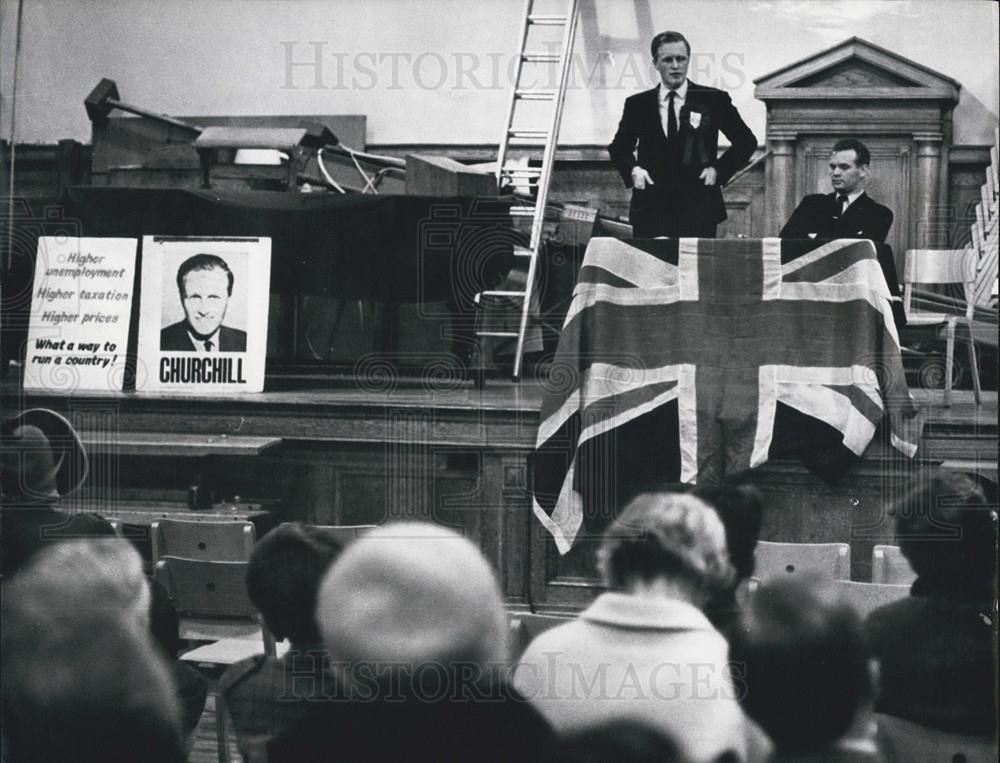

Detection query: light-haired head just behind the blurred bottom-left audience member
(22, 537), (150, 630)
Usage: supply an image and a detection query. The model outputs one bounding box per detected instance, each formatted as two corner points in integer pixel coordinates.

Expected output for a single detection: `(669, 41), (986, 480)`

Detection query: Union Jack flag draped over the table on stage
(533, 238), (920, 553)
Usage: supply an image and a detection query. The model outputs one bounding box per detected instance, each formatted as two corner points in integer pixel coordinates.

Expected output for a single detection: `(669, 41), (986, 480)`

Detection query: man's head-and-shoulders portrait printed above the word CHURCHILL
(160, 254), (247, 352)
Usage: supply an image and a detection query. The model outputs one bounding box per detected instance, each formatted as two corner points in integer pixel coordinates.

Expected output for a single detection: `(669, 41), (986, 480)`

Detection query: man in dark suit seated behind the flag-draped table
(781, 138), (892, 244)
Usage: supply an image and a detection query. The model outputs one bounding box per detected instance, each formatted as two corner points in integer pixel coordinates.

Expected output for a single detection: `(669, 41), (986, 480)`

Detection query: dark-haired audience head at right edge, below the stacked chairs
(894, 469), (997, 593)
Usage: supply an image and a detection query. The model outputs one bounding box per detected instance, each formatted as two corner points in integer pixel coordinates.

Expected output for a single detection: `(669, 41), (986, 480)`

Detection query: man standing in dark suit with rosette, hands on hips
(608, 32), (757, 238)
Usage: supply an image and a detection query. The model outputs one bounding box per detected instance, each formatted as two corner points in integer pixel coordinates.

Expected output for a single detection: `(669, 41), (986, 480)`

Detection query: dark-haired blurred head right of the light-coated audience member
(730, 576), (873, 753)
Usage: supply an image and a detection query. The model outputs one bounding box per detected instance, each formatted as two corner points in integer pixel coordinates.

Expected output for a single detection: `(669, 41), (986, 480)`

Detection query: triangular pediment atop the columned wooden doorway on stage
(754, 37), (961, 101)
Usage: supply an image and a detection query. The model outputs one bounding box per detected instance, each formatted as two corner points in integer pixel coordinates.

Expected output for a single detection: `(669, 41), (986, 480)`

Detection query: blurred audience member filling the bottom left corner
(2, 575), (184, 763)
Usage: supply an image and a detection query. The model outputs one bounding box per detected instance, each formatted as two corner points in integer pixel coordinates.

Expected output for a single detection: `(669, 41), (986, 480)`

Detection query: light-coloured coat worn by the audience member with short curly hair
(514, 593), (747, 761)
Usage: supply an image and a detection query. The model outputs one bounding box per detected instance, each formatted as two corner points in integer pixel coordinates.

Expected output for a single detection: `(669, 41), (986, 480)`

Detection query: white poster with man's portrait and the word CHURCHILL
(136, 236), (271, 395)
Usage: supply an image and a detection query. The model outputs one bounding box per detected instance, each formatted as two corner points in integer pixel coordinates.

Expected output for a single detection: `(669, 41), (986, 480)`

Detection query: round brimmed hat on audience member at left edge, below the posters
(0, 408), (89, 504)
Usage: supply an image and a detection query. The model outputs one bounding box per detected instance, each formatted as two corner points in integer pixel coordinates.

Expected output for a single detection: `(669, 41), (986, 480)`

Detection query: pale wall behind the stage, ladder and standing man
(0, 0), (1000, 144)
